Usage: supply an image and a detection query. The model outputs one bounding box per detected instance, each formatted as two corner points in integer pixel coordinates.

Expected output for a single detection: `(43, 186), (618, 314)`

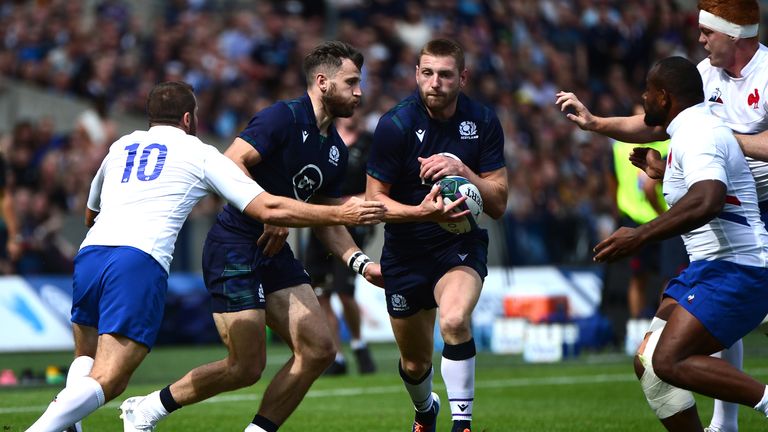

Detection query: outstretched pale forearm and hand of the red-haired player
(555, 91), (669, 143)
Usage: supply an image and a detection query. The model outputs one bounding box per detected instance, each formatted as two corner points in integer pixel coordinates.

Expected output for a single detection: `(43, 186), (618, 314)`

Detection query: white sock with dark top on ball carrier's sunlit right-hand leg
(440, 357), (476, 420)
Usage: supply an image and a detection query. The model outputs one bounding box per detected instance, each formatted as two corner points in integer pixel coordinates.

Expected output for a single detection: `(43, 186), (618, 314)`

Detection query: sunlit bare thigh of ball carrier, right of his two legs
(435, 266), (483, 320)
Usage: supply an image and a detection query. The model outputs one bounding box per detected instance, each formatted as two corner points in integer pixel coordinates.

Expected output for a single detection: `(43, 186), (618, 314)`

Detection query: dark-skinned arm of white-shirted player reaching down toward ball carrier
(594, 180), (726, 262)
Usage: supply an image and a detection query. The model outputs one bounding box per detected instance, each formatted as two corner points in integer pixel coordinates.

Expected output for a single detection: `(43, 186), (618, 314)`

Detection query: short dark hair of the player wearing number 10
(147, 81), (197, 125)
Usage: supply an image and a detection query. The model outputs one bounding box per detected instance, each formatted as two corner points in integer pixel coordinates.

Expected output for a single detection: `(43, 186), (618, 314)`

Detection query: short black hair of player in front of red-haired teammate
(649, 56), (704, 106)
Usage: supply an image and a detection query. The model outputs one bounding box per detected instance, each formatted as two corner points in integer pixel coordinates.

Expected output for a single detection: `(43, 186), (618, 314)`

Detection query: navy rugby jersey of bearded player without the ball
(217, 93), (349, 239)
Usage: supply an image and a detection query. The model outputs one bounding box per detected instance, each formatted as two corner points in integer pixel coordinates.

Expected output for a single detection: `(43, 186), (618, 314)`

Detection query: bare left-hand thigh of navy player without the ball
(213, 309), (266, 364)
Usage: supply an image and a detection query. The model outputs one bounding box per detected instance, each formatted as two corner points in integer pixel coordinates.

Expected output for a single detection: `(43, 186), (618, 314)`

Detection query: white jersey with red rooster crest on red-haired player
(698, 44), (768, 201)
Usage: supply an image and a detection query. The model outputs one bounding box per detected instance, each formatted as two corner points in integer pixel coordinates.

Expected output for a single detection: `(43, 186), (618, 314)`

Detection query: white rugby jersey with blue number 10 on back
(80, 126), (264, 271)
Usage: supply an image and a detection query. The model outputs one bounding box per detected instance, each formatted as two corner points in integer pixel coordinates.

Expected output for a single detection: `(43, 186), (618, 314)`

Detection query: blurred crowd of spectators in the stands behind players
(0, 0), (752, 272)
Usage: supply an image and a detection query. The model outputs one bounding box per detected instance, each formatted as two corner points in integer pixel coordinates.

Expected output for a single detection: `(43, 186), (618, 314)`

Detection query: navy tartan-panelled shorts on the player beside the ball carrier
(203, 229), (311, 313)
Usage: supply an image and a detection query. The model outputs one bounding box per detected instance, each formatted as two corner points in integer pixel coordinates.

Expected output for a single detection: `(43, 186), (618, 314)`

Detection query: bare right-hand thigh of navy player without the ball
(266, 283), (333, 351)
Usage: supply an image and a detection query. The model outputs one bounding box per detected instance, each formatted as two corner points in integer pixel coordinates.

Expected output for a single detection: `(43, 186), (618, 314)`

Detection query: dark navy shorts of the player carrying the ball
(381, 230), (488, 318)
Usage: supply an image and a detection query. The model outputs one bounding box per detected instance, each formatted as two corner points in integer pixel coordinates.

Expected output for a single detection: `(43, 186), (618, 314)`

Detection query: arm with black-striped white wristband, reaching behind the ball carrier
(312, 197), (384, 287)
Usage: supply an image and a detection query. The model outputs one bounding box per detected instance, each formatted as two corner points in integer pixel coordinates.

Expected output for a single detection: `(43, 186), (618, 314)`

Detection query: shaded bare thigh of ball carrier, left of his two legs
(389, 309), (436, 363)
